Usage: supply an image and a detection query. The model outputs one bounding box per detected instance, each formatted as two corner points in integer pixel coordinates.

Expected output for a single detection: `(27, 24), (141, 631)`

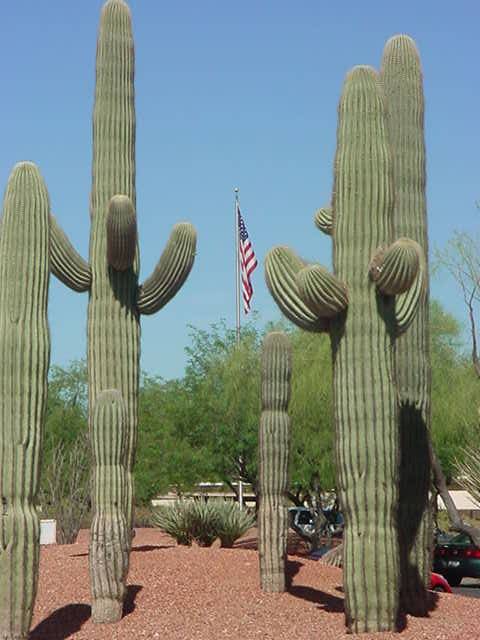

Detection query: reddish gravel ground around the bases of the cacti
(30, 529), (480, 640)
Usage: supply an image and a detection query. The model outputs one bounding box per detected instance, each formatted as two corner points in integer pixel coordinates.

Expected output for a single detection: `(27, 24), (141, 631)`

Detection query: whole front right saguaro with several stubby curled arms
(265, 67), (420, 632)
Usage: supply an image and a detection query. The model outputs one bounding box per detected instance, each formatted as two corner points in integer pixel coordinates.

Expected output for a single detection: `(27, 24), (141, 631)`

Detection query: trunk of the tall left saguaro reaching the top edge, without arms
(88, 0), (140, 622)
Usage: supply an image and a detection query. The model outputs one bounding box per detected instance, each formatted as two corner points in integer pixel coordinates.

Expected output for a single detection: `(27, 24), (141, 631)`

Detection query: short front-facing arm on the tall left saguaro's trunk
(107, 195), (137, 271)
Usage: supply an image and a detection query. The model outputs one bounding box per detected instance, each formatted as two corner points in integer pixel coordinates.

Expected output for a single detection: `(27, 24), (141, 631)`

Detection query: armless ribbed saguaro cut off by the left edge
(0, 162), (50, 640)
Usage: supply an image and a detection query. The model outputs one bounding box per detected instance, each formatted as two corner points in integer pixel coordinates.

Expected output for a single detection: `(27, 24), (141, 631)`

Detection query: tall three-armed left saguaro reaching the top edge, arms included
(52, 0), (196, 622)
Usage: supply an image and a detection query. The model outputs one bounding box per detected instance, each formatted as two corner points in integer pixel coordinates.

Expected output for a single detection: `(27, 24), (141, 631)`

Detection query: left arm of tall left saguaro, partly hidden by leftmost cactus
(50, 213), (92, 292)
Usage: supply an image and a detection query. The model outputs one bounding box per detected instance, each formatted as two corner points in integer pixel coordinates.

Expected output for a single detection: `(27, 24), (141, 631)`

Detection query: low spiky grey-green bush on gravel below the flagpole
(153, 499), (254, 547)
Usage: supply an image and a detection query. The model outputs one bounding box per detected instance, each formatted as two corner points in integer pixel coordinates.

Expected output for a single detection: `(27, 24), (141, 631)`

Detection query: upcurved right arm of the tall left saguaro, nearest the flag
(137, 222), (197, 315)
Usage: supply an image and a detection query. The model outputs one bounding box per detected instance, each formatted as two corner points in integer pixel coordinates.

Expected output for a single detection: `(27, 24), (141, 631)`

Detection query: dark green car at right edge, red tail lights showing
(433, 533), (480, 587)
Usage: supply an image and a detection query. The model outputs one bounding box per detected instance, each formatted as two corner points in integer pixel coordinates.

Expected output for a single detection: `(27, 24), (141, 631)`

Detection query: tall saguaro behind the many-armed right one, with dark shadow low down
(381, 35), (433, 615)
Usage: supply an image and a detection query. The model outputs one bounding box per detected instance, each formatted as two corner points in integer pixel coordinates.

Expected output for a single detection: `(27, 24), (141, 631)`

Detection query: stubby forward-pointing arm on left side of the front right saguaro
(296, 264), (348, 318)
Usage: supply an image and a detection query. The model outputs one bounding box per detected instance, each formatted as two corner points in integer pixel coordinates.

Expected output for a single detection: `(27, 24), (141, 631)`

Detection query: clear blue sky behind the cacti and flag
(0, 0), (480, 378)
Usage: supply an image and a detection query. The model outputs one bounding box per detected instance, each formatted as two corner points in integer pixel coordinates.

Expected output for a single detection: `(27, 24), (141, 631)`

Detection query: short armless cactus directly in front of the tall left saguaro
(89, 389), (130, 622)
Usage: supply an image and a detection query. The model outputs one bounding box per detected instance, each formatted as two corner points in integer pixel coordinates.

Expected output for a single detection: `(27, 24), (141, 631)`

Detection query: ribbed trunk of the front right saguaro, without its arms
(331, 67), (398, 633)
